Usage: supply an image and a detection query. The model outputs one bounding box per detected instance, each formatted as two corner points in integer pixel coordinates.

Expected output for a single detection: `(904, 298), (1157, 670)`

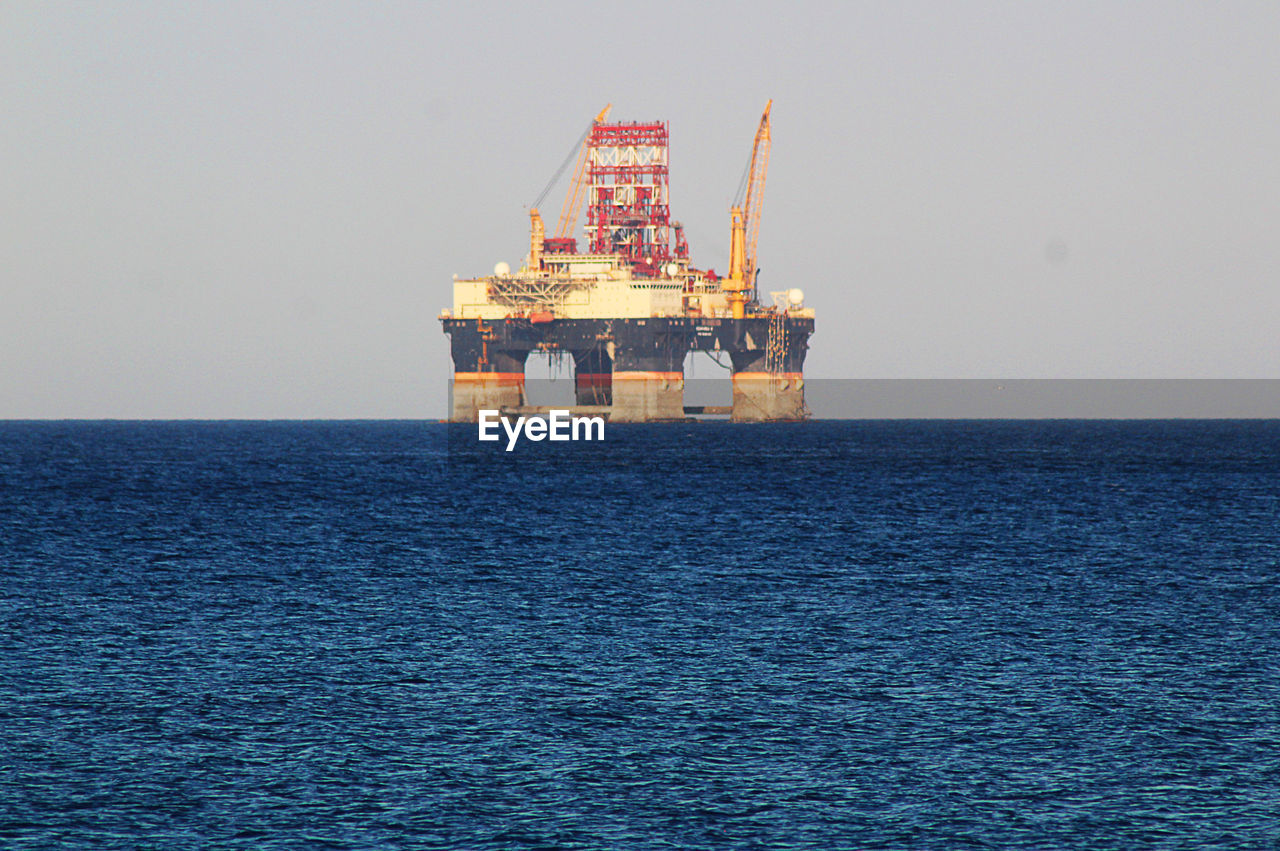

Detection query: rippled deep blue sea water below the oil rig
(0, 421), (1280, 848)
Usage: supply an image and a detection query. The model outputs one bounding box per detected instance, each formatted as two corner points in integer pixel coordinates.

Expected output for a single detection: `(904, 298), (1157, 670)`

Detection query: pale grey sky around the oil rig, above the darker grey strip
(0, 0), (1280, 418)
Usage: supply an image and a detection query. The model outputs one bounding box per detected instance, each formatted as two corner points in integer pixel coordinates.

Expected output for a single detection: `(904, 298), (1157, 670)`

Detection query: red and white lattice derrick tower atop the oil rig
(586, 122), (671, 274)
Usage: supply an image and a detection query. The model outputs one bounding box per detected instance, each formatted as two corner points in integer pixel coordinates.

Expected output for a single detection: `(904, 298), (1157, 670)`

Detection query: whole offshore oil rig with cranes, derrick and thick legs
(440, 101), (814, 422)
